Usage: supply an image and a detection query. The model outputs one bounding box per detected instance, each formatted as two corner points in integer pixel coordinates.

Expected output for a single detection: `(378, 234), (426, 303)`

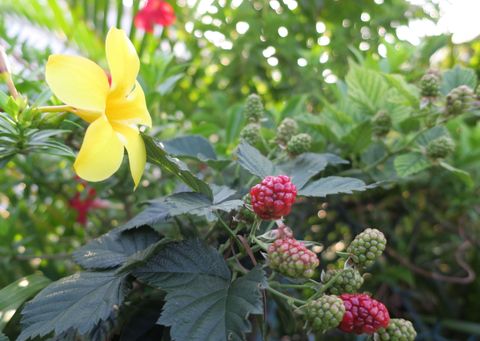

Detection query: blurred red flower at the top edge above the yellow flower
(135, 0), (176, 33)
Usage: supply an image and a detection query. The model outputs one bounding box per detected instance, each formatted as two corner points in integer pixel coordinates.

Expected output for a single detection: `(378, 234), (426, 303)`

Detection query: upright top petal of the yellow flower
(105, 28), (140, 96)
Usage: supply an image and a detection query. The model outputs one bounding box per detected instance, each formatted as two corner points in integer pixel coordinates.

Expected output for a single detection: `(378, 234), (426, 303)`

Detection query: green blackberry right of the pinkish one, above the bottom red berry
(347, 228), (387, 266)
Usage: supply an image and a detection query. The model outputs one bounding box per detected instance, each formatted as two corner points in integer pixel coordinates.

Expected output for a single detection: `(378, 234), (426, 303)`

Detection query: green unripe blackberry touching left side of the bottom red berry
(302, 295), (345, 332)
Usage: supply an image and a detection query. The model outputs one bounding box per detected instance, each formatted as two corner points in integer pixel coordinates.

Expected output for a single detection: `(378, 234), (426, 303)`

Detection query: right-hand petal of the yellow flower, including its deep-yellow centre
(105, 82), (152, 127)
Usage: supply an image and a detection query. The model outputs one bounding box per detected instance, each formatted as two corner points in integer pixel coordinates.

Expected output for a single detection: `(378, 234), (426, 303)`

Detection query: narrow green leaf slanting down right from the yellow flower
(142, 134), (212, 198)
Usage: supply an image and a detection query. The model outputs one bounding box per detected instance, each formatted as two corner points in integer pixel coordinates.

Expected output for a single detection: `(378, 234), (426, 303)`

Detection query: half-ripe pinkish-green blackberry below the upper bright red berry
(267, 236), (320, 278)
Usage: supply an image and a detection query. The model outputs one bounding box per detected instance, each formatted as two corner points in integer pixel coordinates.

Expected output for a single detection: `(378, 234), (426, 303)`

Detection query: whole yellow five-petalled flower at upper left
(46, 28), (152, 187)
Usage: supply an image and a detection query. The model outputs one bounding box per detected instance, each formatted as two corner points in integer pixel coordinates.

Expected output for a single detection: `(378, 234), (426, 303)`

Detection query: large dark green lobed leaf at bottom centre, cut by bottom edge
(134, 240), (266, 341)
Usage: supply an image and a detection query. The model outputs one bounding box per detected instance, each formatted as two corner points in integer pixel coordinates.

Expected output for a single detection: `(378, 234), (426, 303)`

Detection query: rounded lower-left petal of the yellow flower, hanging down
(73, 116), (124, 181)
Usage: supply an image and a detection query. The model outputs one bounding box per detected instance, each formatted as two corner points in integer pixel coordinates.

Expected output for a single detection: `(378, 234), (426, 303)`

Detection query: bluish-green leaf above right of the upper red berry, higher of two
(278, 153), (348, 188)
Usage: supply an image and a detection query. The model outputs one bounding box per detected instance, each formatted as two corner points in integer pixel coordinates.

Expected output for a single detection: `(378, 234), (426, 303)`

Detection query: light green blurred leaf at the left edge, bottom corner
(0, 274), (51, 330)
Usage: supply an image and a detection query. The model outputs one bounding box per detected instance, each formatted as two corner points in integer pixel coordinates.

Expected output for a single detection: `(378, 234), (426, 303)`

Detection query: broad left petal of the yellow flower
(45, 55), (109, 115)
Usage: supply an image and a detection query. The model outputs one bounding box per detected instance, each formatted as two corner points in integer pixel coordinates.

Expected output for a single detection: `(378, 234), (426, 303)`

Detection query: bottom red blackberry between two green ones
(339, 294), (390, 334)
